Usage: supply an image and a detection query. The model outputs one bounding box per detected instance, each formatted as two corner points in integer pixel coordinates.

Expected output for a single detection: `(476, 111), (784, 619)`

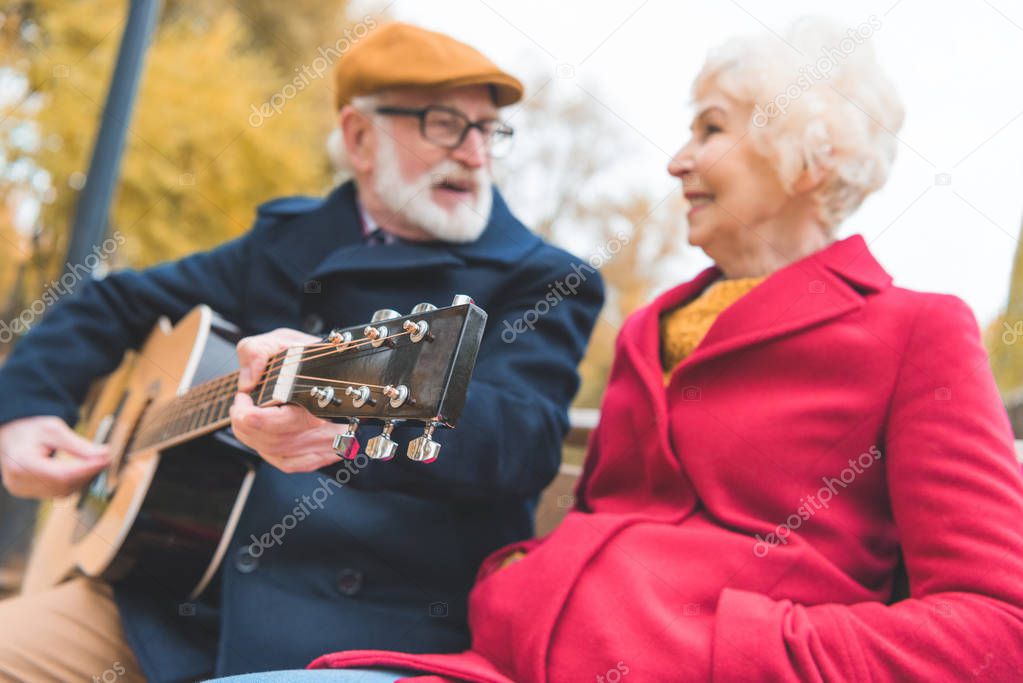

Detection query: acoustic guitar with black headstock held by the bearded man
(23, 294), (487, 599)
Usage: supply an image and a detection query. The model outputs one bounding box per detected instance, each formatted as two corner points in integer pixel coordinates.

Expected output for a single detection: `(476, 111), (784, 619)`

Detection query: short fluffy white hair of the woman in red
(693, 15), (904, 231)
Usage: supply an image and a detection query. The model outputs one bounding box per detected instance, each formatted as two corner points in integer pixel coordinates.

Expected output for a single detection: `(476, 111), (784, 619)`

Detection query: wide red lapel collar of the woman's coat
(626, 235), (892, 392)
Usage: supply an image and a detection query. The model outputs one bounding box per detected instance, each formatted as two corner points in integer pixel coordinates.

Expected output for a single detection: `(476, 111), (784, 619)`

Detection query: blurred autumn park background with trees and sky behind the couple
(0, 0), (1023, 584)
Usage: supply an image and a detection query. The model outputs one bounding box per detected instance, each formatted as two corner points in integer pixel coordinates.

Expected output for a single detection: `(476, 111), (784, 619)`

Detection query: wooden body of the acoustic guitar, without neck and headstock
(23, 306), (255, 598)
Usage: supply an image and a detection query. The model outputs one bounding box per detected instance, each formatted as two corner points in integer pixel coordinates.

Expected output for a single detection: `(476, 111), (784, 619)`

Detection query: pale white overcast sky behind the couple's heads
(353, 0), (1023, 324)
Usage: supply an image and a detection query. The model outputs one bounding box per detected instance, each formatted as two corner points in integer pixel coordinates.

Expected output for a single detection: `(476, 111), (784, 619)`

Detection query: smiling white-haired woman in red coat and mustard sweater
(221, 14), (1023, 683)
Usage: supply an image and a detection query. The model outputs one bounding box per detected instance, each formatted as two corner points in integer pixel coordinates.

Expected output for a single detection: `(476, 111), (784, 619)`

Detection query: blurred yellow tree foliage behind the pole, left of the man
(0, 0), (345, 290)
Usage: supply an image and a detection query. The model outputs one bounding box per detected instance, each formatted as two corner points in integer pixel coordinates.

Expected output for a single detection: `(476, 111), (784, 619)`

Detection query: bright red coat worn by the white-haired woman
(312, 236), (1023, 683)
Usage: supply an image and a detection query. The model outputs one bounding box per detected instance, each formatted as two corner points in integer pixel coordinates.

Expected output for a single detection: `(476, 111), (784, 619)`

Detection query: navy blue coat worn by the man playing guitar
(0, 183), (603, 681)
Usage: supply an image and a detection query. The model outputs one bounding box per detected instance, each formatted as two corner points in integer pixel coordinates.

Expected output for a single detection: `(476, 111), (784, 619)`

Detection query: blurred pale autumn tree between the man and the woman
(495, 79), (686, 408)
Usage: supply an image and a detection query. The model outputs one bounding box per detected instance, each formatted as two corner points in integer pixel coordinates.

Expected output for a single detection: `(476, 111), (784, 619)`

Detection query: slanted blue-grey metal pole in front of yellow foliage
(66, 0), (161, 279)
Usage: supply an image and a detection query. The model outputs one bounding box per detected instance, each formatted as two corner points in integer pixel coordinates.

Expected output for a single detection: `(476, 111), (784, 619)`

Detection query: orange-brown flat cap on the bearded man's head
(333, 21), (523, 109)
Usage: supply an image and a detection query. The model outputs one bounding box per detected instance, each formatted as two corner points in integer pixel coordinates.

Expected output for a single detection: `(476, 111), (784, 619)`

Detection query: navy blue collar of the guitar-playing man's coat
(264, 181), (540, 283)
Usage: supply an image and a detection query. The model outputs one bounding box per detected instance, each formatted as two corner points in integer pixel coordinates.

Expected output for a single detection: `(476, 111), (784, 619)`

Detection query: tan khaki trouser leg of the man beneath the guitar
(0, 579), (145, 683)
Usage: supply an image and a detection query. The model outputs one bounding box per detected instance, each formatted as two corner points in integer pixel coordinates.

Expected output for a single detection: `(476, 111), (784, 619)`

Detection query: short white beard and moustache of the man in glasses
(373, 135), (493, 242)
